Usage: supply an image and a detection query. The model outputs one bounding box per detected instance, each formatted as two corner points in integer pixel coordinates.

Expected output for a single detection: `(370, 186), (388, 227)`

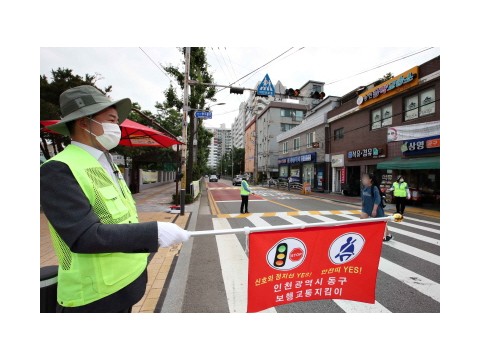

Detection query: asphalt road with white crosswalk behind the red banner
(182, 180), (440, 313)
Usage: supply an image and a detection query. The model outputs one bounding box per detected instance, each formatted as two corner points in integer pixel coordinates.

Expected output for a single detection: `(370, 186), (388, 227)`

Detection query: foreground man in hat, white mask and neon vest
(40, 85), (190, 312)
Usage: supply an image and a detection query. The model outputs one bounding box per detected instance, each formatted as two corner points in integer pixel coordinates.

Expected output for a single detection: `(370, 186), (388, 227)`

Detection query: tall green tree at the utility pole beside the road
(165, 47), (215, 191)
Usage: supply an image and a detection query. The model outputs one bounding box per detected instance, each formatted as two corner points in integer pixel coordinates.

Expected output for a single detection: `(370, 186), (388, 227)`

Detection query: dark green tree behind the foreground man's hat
(40, 68), (112, 159)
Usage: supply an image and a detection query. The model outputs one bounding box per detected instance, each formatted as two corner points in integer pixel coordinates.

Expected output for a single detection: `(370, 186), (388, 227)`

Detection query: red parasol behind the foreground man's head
(40, 119), (182, 148)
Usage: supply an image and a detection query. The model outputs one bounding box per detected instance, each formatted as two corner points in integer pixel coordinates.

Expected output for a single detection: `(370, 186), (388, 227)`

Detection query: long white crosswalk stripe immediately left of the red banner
(212, 218), (277, 313)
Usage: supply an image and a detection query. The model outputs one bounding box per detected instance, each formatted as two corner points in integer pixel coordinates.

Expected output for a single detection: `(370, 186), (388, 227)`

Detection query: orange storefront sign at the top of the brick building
(357, 66), (418, 107)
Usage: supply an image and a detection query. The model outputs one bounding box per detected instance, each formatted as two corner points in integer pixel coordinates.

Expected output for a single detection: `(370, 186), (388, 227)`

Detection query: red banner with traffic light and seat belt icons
(247, 221), (385, 312)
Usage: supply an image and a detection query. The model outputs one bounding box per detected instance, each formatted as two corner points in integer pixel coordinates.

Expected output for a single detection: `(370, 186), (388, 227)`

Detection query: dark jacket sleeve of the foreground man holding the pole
(40, 160), (158, 254)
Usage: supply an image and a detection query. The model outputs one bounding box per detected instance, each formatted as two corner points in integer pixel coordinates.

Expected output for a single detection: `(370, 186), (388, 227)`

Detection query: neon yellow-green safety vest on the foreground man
(43, 145), (148, 307)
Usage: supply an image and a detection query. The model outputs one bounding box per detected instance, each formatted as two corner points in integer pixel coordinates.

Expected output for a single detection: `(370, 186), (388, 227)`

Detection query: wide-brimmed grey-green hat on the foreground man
(48, 85), (132, 136)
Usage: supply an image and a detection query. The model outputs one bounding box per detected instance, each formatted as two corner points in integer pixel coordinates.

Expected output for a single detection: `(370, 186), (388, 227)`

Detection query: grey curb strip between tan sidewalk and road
(160, 193), (202, 313)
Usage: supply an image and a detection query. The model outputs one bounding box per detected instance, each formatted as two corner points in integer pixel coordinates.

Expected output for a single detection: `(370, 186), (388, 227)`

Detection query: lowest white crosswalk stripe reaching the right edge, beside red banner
(379, 258), (440, 302)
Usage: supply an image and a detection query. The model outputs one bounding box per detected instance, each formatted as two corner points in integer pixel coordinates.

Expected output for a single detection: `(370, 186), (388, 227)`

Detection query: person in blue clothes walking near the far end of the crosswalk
(360, 174), (393, 241)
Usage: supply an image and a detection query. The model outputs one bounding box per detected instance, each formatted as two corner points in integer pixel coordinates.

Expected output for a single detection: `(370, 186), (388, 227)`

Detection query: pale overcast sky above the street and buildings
(40, 46), (440, 127)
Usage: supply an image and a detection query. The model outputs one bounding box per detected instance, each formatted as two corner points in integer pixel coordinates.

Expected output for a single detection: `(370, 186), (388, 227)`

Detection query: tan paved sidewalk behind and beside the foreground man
(40, 183), (191, 313)
